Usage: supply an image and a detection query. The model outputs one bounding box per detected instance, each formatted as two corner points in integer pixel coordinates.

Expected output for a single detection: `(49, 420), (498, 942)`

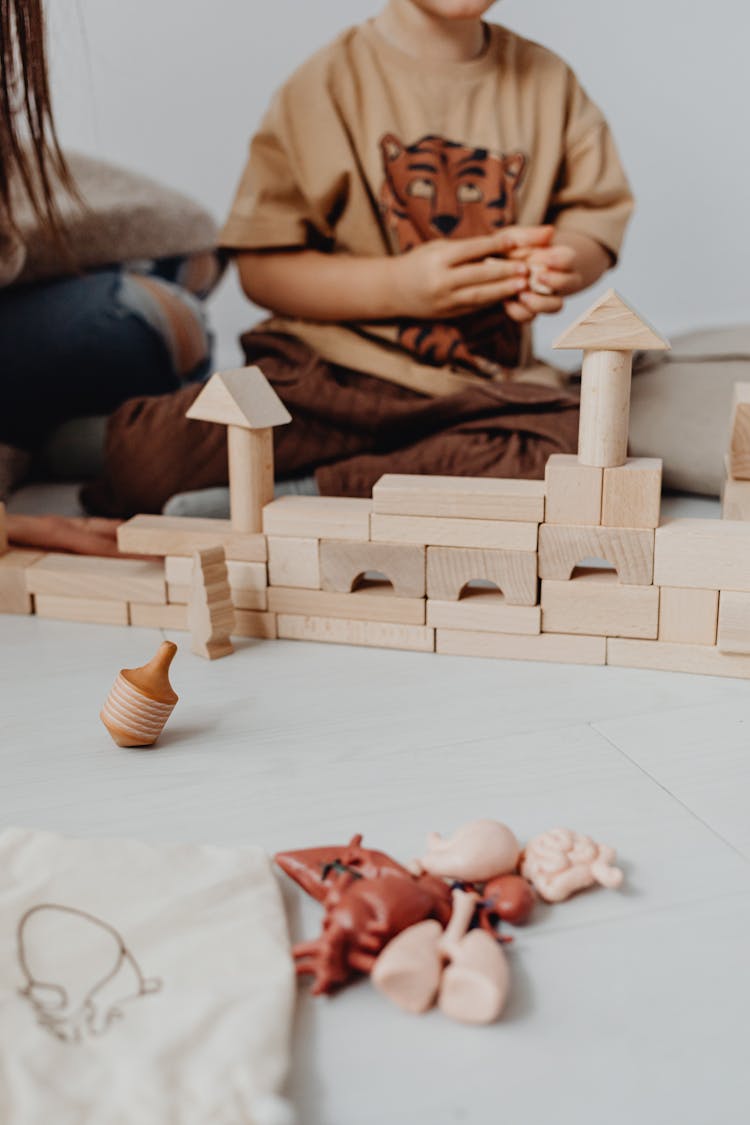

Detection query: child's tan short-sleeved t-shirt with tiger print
(222, 21), (633, 394)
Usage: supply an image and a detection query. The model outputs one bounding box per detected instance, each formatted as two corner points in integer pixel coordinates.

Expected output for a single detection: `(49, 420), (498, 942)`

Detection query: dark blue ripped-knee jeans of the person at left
(0, 269), (210, 449)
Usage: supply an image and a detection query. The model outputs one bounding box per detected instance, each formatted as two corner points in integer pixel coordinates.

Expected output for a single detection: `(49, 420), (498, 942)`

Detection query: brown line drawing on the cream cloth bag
(17, 902), (163, 1043)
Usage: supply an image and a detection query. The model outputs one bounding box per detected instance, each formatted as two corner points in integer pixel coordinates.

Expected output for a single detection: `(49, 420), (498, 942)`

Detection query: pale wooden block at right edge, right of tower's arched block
(653, 520), (750, 591)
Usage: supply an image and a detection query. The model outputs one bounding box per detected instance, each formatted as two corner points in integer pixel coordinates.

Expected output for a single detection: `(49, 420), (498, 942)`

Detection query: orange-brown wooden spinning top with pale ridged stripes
(99, 640), (179, 746)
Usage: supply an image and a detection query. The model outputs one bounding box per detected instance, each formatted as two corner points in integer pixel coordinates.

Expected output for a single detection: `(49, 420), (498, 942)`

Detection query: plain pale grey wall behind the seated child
(48, 0), (750, 363)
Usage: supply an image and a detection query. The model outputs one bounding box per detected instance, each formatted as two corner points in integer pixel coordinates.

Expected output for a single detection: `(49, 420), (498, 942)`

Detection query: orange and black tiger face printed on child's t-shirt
(380, 133), (526, 253)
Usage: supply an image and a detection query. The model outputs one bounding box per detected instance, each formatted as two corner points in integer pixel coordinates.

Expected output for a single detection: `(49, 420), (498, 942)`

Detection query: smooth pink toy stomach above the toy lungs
(415, 820), (521, 883)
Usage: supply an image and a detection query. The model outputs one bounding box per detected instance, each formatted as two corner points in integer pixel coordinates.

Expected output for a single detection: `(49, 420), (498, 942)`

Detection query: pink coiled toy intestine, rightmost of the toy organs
(521, 828), (623, 902)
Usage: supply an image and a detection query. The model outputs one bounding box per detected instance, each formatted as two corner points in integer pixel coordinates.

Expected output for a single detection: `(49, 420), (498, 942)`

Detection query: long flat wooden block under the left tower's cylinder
(117, 515), (266, 563)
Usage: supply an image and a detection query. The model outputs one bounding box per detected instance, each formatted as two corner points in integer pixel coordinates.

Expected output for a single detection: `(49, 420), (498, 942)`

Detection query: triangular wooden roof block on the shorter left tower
(187, 367), (291, 430)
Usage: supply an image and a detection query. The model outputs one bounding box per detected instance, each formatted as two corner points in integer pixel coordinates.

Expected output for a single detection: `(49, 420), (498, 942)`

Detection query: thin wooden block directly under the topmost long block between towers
(370, 513), (539, 551)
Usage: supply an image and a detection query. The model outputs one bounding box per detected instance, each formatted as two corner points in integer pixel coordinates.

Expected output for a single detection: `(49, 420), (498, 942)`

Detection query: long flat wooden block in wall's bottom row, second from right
(436, 629), (607, 664)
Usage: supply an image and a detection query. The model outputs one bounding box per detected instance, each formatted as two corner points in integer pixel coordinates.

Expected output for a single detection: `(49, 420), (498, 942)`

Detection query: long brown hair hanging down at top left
(0, 0), (76, 244)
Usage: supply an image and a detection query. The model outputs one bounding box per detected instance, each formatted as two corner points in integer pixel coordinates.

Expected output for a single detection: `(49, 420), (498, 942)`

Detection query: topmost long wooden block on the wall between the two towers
(372, 474), (544, 523)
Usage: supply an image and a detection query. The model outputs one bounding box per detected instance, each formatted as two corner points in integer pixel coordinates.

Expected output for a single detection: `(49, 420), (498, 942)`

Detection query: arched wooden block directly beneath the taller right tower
(539, 523), (653, 586)
